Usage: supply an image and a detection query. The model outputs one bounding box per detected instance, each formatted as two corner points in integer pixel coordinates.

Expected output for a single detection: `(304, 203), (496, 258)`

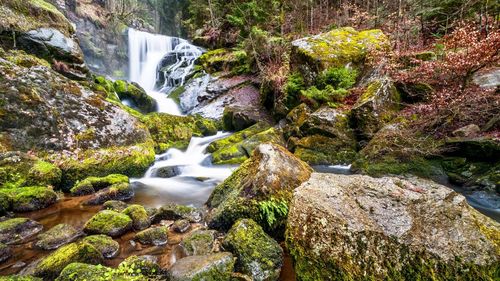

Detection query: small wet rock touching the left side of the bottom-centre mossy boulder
(181, 230), (216, 256)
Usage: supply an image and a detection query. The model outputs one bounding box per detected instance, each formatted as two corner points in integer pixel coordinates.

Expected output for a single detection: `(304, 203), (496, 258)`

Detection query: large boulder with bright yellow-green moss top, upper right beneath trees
(290, 27), (390, 84)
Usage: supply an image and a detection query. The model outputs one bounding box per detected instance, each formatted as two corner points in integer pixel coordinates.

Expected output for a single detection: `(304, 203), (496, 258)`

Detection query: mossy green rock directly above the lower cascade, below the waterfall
(142, 113), (217, 153)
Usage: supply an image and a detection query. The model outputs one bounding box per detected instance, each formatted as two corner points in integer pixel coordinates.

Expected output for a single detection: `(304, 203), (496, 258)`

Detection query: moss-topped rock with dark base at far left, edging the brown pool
(10, 186), (57, 212)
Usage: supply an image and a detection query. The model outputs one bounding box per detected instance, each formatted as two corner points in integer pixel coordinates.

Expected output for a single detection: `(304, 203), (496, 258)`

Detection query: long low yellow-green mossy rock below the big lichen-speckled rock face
(57, 142), (155, 191)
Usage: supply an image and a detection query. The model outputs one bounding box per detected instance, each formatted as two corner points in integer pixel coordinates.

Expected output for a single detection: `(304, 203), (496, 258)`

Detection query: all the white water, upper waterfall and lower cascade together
(128, 29), (233, 207)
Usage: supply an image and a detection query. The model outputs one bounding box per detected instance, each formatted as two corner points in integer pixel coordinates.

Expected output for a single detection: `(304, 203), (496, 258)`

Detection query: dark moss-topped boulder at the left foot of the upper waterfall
(114, 80), (158, 113)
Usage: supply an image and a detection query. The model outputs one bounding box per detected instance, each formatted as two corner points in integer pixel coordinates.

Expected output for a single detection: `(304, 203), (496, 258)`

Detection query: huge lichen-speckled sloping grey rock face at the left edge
(0, 50), (149, 151)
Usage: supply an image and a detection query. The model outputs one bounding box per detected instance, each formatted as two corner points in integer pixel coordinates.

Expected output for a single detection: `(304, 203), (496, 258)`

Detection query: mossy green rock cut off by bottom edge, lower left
(56, 262), (107, 281)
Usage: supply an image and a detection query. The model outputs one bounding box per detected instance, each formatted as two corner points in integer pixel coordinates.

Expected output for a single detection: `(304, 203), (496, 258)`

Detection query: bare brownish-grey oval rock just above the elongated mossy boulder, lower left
(35, 223), (84, 250)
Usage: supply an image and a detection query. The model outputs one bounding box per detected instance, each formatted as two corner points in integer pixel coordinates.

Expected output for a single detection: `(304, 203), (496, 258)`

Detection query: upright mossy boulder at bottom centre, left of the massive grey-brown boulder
(223, 219), (283, 281)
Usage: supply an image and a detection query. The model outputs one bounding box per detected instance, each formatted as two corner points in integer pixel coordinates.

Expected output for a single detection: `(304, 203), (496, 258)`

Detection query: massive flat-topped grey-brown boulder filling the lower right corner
(286, 173), (500, 280)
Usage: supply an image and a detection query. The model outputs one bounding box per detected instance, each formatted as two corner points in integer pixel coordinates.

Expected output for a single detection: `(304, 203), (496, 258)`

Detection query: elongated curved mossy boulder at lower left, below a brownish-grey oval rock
(33, 242), (103, 280)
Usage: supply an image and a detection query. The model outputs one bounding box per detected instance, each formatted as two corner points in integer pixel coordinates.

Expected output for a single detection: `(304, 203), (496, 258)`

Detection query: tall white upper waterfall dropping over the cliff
(128, 28), (202, 115)
